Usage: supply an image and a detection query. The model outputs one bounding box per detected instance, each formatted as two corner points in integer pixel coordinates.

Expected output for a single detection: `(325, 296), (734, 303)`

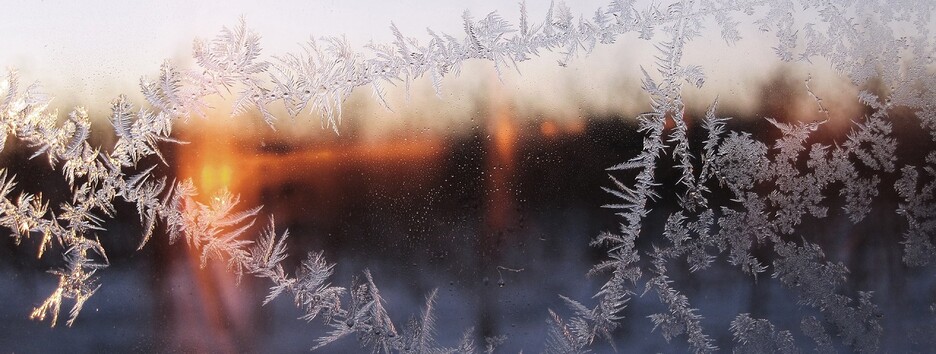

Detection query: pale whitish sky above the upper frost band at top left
(0, 0), (605, 101)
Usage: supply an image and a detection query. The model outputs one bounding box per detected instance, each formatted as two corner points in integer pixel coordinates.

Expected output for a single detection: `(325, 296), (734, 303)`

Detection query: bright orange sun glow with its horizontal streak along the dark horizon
(177, 117), (446, 216)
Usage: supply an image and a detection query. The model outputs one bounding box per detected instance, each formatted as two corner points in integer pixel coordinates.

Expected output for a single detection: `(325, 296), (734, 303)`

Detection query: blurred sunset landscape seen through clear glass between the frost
(0, 1), (936, 353)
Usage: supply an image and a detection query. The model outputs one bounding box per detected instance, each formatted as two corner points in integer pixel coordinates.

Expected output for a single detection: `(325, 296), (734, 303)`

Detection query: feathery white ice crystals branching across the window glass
(0, 0), (936, 353)
